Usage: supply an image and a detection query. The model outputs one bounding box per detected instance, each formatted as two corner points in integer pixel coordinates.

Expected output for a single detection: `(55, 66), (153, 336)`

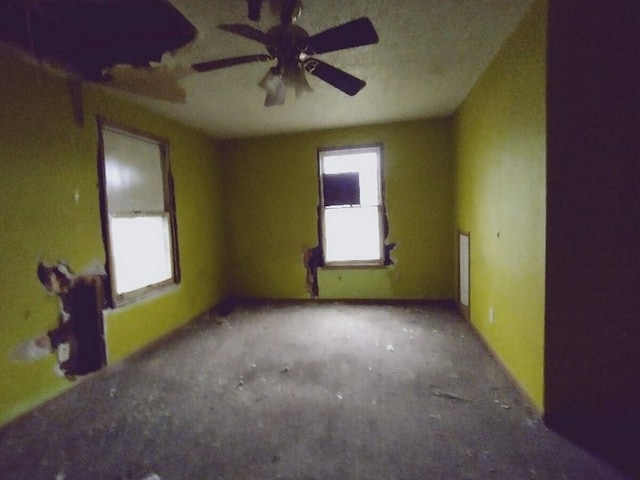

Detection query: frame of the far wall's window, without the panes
(317, 143), (388, 269)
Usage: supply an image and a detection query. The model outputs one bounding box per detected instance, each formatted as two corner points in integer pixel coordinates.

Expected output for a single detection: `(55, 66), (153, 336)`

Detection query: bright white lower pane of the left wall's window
(109, 214), (173, 294)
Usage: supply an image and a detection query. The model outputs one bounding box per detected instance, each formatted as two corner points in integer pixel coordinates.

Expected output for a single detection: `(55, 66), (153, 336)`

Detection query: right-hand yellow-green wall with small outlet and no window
(455, 1), (546, 408)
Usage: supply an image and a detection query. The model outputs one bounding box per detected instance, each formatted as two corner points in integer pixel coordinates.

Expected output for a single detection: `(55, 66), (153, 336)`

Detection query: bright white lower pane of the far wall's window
(324, 207), (381, 262)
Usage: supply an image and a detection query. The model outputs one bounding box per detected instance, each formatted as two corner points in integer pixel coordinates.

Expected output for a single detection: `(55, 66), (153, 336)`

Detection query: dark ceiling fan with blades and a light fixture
(191, 0), (378, 107)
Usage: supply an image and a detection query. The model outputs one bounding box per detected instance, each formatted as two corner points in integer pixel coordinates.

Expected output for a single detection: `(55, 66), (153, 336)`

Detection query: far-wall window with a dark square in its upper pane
(318, 145), (386, 266)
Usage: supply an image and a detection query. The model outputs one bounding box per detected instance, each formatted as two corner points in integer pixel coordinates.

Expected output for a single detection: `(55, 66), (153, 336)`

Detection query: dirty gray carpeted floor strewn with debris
(0, 303), (626, 480)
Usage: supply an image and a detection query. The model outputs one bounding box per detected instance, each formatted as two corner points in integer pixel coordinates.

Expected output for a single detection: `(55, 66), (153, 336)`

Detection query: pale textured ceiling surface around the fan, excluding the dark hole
(6, 0), (532, 138)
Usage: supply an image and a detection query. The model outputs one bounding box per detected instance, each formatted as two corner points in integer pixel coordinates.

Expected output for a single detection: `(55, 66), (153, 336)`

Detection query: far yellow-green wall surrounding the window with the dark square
(221, 119), (454, 299)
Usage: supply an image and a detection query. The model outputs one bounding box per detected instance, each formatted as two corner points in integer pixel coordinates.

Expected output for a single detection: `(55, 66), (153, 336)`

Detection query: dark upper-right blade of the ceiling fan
(303, 17), (378, 55)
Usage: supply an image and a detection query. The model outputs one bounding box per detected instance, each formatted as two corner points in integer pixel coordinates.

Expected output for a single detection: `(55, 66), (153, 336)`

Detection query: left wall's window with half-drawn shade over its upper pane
(99, 121), (179, 305)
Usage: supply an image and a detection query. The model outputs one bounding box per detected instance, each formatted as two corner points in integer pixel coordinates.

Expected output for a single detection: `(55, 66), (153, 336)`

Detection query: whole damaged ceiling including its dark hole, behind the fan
(0, 0), (543, 138)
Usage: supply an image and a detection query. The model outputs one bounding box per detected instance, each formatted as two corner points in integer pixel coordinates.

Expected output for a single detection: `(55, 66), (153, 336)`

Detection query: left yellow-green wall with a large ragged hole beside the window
(0, 52), (225, 424)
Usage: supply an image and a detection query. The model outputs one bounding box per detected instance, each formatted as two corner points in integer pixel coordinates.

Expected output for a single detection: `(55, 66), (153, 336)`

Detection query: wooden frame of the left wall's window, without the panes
(96, 120), (181, 308)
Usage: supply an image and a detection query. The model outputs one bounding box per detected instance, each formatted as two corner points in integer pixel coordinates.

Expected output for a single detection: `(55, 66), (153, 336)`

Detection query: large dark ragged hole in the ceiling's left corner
(0, 0), (197, 81)
